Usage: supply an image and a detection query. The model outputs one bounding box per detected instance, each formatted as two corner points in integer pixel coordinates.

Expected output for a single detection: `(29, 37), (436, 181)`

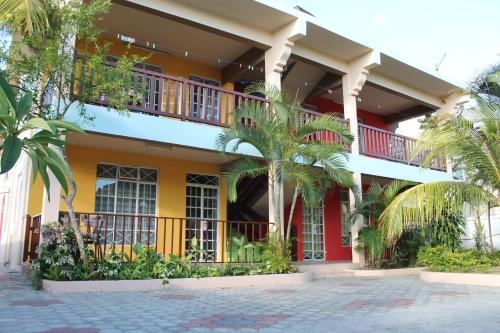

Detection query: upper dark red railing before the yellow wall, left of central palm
(74, 56), (269, 127)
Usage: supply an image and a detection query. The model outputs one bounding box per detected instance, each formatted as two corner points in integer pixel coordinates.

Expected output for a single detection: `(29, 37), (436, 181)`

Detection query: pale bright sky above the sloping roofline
(276, 0), (500, 85)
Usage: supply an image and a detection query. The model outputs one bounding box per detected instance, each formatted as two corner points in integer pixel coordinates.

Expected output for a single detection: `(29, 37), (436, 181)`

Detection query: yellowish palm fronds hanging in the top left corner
(0, 0), (52, 35)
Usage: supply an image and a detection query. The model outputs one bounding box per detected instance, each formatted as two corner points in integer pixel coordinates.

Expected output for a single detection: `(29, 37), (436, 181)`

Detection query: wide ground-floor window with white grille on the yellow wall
(95, 164), (158, 245)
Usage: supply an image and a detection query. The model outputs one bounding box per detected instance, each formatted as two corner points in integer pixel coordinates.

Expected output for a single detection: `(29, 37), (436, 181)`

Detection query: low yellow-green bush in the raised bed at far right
(417, 246), (495, 273)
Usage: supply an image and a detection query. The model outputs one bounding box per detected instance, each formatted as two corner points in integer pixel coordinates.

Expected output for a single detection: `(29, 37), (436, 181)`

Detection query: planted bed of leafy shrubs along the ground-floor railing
(29, 223), (297, 289)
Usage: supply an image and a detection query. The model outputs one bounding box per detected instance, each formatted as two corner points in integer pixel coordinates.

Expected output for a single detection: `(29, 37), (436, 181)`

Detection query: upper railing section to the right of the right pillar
(358, 124), (446, 171)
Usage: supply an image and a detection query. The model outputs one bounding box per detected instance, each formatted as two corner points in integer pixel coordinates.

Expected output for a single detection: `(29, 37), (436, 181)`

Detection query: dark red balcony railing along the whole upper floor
(75, 58), (446, 171)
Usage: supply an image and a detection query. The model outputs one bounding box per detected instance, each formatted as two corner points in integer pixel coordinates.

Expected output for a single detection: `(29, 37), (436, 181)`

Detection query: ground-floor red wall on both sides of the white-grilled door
(285, 187), (352, 261)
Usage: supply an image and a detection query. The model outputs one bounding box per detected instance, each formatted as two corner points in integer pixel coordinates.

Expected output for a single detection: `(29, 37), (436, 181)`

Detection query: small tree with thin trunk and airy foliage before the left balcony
(0, 0), (144, 264)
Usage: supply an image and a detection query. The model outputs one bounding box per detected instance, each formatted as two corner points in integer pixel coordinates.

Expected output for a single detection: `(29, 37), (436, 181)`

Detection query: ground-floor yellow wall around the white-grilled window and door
(60, 146), (227, 260)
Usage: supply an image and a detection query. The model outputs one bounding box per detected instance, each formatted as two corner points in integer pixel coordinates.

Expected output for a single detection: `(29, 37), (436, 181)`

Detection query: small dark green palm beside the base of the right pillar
(350, 180), (414, 267)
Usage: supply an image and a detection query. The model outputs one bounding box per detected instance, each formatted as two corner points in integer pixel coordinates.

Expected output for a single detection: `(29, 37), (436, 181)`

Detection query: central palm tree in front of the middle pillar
(217, 83), (352, 246)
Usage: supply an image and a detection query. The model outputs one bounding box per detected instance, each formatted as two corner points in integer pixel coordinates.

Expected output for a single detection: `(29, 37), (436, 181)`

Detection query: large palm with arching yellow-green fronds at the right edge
(380, 65), (500, 245)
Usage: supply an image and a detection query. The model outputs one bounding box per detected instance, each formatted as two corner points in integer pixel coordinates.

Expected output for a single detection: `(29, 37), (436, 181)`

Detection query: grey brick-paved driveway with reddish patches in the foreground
(0, 274), (500, 333)
